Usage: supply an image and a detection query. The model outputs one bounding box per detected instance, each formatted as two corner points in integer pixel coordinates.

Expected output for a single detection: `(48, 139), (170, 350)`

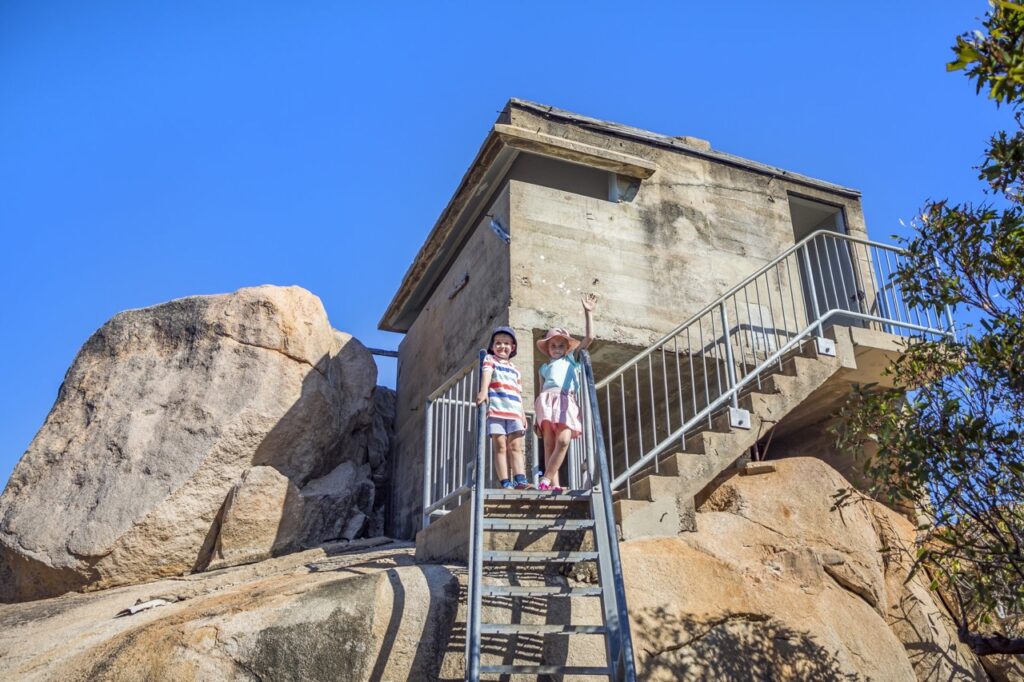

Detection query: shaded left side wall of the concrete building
(388, 187), (509, 538)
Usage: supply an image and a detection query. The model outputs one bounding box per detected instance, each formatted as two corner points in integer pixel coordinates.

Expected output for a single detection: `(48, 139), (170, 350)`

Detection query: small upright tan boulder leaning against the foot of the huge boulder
(209, 467), (303, 569)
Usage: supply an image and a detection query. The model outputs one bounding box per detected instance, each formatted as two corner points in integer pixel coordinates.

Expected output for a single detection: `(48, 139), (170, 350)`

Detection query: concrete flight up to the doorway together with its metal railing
(595, 230), (953, 516)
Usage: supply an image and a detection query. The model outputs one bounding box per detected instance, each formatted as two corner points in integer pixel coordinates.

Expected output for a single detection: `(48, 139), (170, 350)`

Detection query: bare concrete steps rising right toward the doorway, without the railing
(614, 340), (849, 540)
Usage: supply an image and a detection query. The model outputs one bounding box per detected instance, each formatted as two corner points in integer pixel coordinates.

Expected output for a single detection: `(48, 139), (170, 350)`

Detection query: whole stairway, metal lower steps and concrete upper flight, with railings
(423, 230), (953, 680)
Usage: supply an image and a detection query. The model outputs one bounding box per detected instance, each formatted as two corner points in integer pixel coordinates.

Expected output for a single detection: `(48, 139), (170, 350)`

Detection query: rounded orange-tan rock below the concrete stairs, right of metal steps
(623, 458), (987, 681)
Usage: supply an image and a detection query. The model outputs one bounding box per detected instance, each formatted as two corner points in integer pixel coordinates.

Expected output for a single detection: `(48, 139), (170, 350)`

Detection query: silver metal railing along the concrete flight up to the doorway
(595, 230), (953, 495)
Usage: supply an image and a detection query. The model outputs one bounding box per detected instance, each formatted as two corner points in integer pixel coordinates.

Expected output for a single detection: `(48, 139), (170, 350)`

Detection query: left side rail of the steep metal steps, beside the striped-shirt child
(466, 350), (487, 681)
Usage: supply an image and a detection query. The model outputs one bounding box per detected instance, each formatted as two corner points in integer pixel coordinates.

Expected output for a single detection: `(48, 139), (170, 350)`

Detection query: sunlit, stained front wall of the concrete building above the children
(510, 109), (866, 393)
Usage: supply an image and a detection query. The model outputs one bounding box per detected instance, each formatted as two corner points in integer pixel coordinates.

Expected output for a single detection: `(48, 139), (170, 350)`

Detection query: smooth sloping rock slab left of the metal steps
(0, 543), (459, 682)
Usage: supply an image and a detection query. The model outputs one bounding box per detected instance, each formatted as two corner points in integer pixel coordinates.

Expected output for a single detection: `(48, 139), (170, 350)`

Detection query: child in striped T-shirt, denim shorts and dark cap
(476, 327), (531, 491)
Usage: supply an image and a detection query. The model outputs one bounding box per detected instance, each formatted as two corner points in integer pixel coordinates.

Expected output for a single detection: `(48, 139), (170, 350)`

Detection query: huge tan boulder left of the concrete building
(0, 287), (376, 601)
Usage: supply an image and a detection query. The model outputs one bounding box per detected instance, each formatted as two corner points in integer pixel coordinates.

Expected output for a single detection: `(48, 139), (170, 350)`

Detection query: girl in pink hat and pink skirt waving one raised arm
(535, 294), (597, 493)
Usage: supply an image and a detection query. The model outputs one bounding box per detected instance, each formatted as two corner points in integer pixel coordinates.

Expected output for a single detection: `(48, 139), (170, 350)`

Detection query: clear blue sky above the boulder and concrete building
(0, 0), (1008, 483)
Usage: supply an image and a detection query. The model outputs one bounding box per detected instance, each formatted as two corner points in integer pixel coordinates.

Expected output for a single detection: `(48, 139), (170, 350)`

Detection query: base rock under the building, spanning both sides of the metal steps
(0, 458), (988, 682)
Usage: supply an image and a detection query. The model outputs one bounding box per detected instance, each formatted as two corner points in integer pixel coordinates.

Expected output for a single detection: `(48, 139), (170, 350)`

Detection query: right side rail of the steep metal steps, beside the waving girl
(580, 350), (636, 682)
